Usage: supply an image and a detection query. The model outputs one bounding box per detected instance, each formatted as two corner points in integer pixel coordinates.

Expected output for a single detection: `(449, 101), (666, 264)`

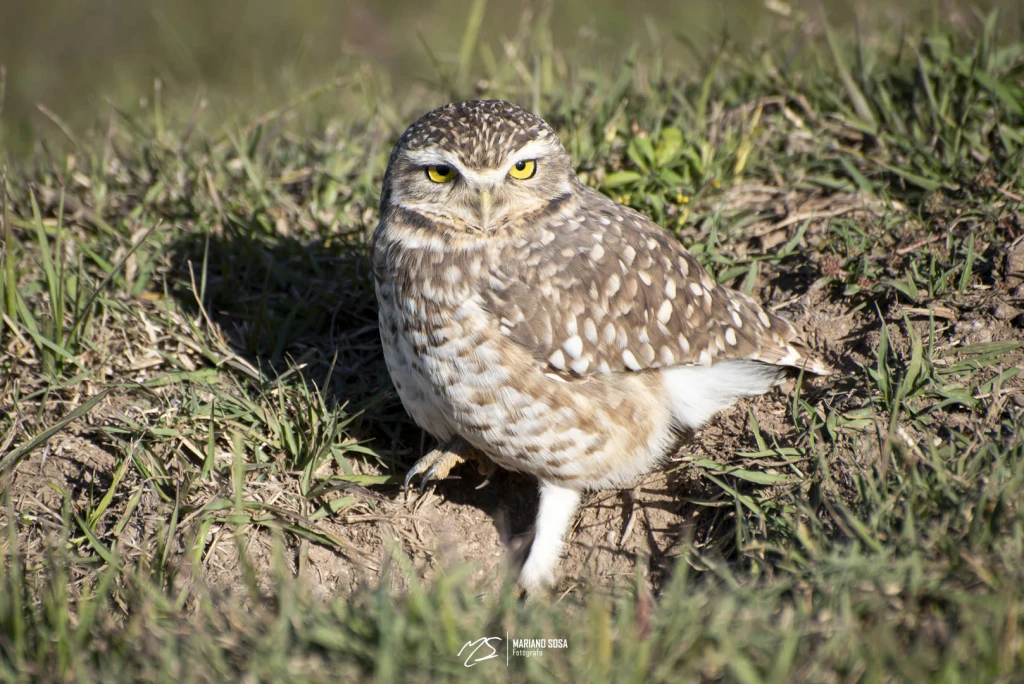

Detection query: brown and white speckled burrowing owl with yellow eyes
(372, 100), (826, 591)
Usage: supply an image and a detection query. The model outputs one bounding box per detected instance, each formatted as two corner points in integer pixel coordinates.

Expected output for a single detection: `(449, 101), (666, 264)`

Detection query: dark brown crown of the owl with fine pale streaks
(392, 99), (557, 168)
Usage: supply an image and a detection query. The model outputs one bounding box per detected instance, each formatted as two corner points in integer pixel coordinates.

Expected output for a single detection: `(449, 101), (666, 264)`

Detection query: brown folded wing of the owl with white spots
(484, 189), (827, 376)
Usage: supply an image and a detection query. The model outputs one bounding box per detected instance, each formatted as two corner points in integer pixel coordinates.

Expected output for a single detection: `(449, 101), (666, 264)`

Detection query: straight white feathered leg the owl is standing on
(519, 481), (581, 593)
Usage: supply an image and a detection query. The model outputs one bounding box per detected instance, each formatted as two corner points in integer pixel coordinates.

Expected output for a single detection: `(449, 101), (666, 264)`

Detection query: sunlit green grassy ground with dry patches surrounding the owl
(0, 6), (1024, 682)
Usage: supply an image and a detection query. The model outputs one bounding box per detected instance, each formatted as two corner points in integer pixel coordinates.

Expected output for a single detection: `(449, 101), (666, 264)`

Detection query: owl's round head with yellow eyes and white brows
(381, 100), (580, 232)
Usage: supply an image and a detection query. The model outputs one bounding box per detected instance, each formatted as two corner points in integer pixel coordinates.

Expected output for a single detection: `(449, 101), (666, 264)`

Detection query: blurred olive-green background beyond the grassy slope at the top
(0, 0), (1024, 148)
